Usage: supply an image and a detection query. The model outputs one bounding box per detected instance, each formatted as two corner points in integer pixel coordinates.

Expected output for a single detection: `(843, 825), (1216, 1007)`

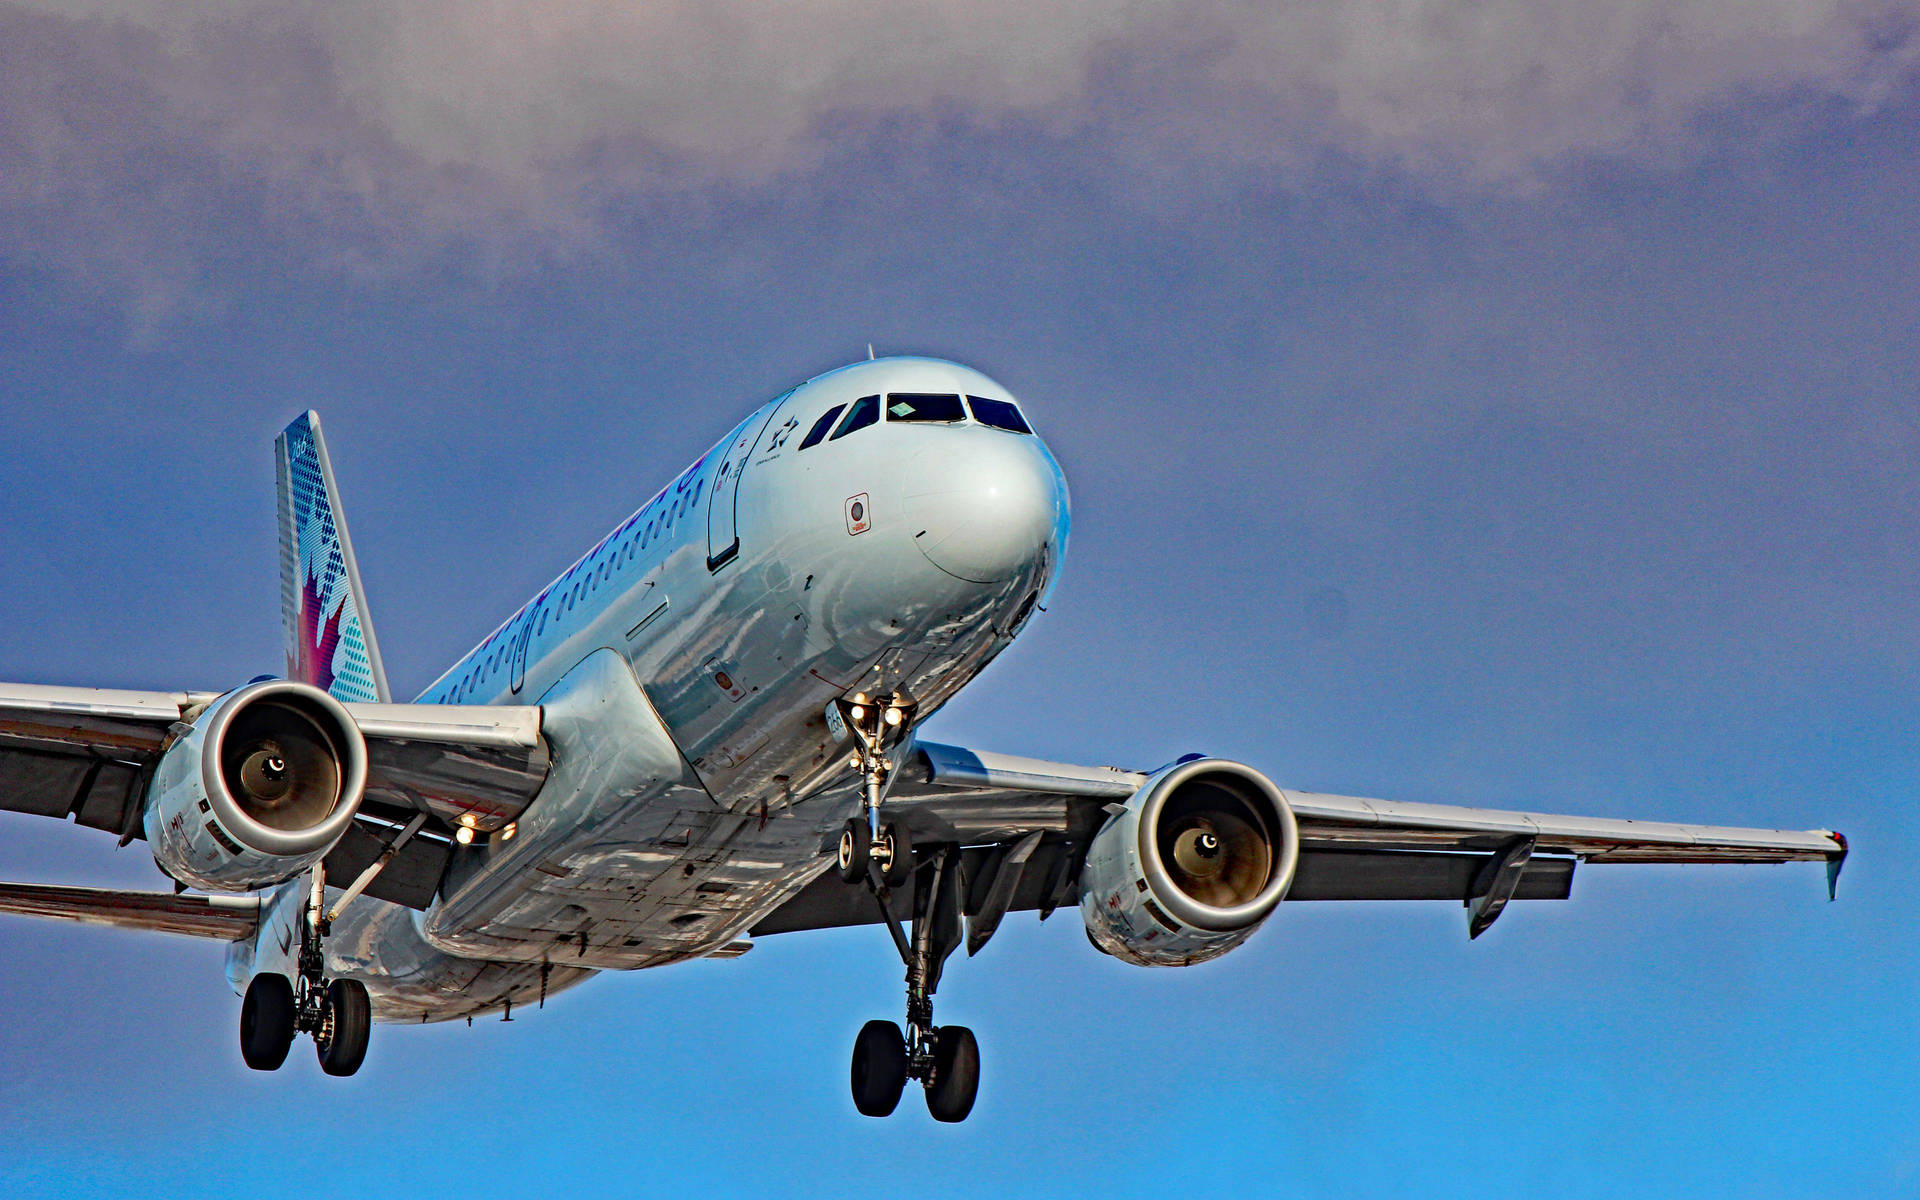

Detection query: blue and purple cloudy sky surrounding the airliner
(0, 0), (1920, 1196)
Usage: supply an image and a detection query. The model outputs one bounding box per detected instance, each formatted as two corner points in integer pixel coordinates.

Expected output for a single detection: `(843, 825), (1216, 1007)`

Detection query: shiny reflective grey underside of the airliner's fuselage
(357, 526), (1033, 1002)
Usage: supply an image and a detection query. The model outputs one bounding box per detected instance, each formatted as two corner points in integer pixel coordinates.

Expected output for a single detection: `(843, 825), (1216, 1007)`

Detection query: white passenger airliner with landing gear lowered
(0, 355), (1847, 1121)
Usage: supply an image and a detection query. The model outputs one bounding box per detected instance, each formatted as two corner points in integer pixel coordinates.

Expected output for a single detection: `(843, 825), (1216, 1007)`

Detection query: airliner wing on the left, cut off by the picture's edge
(0, 684), (549, 908)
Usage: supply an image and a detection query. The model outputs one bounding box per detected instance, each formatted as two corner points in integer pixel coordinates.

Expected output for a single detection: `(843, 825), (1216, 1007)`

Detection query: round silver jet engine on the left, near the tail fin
(144, 680), (367, 891)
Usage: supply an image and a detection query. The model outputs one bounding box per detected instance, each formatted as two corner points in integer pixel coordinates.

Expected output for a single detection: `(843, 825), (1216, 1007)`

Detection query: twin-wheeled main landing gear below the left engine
(240, 866), (372, 1075)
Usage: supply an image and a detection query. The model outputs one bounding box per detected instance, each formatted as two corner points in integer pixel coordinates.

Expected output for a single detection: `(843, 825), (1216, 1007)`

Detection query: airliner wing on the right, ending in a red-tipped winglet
(753, 743), (1847, 945)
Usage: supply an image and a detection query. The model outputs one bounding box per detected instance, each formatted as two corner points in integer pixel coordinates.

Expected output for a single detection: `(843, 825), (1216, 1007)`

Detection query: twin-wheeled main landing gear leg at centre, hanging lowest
(852, 847), (979, 1121)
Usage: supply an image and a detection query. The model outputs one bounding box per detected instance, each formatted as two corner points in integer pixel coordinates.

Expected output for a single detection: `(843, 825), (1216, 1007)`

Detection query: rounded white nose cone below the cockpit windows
(906, 428), (1068, 584)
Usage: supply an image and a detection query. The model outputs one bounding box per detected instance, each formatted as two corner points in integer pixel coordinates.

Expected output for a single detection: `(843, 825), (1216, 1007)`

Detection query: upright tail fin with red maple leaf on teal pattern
(273, 413), (392, 703)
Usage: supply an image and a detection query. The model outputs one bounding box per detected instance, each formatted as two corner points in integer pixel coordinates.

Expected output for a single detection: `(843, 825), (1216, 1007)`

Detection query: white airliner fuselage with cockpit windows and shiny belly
(228, 359), (1068, 1021)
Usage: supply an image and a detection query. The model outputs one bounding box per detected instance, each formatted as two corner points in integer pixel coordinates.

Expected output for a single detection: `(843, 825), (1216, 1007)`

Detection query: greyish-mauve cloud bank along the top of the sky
(0, 0), (1920, 318)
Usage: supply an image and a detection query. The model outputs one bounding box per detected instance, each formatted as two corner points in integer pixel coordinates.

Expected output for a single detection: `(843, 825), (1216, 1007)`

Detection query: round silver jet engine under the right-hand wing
(1081, 758), (1300, 966)
